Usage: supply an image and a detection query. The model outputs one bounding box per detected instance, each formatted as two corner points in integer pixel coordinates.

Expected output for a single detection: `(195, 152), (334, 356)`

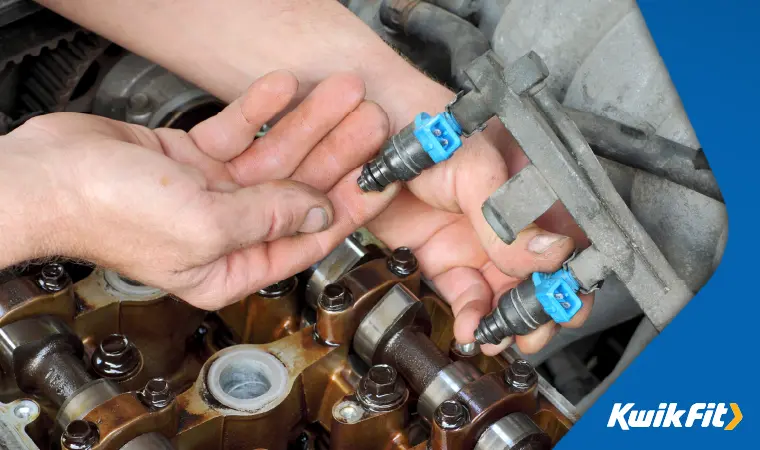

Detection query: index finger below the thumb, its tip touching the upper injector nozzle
(176, 169), (399, 310)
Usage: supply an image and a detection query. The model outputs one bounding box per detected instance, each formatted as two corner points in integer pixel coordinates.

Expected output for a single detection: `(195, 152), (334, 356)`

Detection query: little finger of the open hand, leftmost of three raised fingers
(188, 70), (298, 162)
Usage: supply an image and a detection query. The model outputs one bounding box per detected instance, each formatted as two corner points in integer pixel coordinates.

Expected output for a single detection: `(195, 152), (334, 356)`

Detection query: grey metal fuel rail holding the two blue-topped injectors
(452, 52), (693, 330)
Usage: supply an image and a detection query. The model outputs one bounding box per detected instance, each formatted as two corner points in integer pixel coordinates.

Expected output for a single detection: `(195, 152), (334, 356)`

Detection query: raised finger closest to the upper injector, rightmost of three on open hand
(291, 101), (389, 192)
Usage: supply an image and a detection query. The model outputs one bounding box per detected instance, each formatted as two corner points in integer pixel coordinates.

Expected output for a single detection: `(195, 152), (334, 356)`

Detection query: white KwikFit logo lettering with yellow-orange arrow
(607, 403), (742, 431)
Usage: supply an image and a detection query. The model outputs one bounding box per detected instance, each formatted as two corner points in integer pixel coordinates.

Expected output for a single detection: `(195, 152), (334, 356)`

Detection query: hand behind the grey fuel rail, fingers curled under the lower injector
(362, 90), (593, 355)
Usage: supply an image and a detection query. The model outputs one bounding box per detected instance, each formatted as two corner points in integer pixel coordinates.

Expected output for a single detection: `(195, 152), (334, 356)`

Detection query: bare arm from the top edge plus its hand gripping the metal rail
(37, 0), (593, 354)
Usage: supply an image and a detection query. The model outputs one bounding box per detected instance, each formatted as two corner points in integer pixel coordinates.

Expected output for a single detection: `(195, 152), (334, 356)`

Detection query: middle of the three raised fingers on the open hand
(229, 74), (365, 186)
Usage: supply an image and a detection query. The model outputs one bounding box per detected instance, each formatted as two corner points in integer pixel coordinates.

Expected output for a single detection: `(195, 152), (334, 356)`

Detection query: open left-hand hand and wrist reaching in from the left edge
(0, 71), (398, 309)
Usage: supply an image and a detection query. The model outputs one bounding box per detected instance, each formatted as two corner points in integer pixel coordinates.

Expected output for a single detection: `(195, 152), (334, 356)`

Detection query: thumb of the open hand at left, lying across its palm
(213, 180), (333, 251)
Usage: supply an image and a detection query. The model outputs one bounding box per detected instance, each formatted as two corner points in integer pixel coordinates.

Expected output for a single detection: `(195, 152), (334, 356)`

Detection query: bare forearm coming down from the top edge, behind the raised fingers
(39, 0), (451, 131)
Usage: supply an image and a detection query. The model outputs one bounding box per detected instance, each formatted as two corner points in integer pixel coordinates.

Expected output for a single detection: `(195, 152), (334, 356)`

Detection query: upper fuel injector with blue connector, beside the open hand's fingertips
(357, 111), (470, 192)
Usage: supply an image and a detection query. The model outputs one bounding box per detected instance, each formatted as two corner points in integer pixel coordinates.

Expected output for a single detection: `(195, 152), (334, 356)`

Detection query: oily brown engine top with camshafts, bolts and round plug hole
(0, 235), (573, 450)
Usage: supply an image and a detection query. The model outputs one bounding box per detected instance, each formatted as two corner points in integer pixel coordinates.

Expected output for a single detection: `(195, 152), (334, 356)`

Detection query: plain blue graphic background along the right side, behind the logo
(557, 0), (760, 450)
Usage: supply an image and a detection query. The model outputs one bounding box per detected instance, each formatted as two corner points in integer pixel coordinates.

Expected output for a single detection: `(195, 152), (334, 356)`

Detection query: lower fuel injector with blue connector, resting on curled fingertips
(475, 268), (583, 344)
